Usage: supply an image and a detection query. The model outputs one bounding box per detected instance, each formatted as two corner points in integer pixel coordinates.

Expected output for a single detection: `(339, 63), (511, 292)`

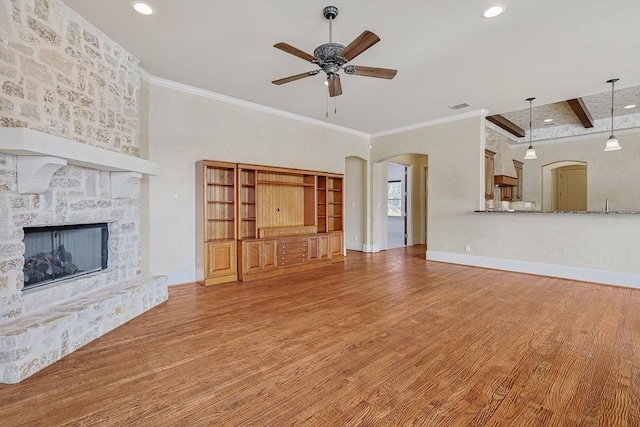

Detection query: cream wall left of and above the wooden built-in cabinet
(149, 79), (369, 284)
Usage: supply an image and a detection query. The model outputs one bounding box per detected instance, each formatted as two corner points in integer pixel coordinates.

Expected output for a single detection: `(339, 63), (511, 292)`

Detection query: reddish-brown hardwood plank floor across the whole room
(0, 246), (640, 427)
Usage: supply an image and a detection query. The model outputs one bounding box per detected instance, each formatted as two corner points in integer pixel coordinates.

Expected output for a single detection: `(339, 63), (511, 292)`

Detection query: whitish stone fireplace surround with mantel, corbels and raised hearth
(0, 128), (168, 384)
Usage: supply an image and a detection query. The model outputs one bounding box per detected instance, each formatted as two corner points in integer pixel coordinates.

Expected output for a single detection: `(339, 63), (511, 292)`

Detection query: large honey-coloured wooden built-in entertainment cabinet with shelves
(196, 160), (344, 285)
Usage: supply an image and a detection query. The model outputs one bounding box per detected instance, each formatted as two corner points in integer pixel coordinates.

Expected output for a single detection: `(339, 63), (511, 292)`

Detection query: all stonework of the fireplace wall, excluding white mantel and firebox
(0, 0), (167, 383)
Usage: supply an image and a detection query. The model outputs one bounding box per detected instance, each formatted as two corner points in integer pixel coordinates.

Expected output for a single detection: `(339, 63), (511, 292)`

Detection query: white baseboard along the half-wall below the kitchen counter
(427, 250), (640, 288)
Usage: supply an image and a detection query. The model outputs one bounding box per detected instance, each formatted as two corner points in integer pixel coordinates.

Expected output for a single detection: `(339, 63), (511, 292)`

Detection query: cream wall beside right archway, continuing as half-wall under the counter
(372, 116), (640, 287)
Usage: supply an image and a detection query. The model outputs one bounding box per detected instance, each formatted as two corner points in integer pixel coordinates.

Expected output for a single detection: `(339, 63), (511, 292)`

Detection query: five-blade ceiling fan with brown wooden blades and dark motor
(271, 6), (398, 97)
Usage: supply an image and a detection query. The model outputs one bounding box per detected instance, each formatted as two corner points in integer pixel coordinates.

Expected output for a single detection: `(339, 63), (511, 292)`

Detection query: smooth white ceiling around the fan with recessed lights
(62, 0), (640, 134)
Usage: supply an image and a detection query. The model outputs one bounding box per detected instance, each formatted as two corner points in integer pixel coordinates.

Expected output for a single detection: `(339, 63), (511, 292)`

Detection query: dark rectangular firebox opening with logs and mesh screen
(23, 223), (109, 290)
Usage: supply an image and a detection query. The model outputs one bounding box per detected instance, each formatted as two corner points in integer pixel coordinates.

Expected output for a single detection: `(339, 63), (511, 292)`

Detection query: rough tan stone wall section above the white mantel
(0, 0), (141, 156)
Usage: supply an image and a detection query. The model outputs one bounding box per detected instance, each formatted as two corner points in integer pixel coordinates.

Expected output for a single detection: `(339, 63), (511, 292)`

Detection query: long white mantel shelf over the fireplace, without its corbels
(0, 127), (159, 175)
